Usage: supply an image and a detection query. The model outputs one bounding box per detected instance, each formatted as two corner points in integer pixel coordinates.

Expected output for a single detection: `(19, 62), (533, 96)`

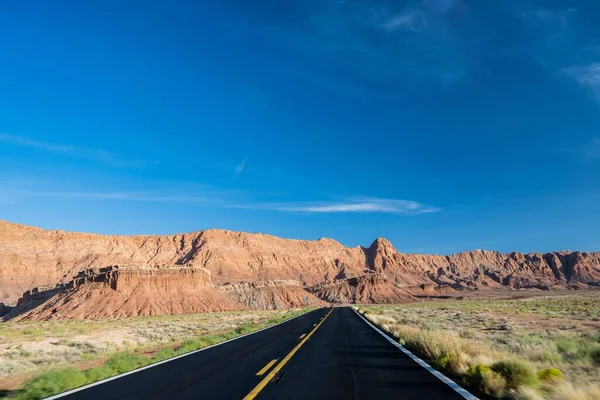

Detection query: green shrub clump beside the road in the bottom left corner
(15, 368), (87, 400)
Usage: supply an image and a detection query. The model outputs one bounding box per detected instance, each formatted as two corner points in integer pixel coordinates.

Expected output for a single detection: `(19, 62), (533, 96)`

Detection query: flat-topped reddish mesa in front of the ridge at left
(4, 266), (246, 321)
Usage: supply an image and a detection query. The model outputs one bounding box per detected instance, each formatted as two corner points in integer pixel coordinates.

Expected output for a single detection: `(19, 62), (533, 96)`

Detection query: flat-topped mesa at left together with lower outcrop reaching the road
(2, 264), (326, 321)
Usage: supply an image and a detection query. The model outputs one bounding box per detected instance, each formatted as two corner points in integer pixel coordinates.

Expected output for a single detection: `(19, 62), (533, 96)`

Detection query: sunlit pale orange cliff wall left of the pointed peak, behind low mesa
(0, 221), (367, 304)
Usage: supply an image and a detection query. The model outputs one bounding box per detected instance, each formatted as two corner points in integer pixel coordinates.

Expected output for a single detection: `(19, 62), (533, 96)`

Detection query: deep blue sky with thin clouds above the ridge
(0, 0), (600, 254)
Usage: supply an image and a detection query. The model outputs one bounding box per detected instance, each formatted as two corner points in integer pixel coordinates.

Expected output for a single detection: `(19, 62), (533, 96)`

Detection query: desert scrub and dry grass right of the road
(359, 293), (600, 400)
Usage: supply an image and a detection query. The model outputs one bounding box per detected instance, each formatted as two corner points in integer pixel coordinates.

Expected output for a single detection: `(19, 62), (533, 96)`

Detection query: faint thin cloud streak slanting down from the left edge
(0, 133), (147, 167)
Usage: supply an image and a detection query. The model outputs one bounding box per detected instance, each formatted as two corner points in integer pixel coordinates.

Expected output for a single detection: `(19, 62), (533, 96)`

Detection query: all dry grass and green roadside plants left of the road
(0, 309), (311, 400)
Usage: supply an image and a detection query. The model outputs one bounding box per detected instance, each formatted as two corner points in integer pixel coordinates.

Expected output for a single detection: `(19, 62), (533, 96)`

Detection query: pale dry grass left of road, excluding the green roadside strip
(0, 311), (304, 389)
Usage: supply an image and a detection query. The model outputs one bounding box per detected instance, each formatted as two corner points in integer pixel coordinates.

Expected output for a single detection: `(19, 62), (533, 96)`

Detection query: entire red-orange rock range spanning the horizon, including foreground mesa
(0, 221), (600, 320)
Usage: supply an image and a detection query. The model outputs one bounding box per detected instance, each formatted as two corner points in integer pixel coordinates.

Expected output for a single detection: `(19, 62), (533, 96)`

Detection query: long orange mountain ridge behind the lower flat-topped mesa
(0, 221), (600, 320)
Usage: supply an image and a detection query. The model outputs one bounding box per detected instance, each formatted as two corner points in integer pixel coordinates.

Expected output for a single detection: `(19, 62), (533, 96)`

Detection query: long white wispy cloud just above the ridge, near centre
(236, 197), (441, 215)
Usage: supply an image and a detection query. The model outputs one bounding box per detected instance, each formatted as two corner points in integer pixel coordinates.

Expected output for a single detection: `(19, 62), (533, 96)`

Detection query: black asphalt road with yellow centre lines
(54, 308), (472, 400)
